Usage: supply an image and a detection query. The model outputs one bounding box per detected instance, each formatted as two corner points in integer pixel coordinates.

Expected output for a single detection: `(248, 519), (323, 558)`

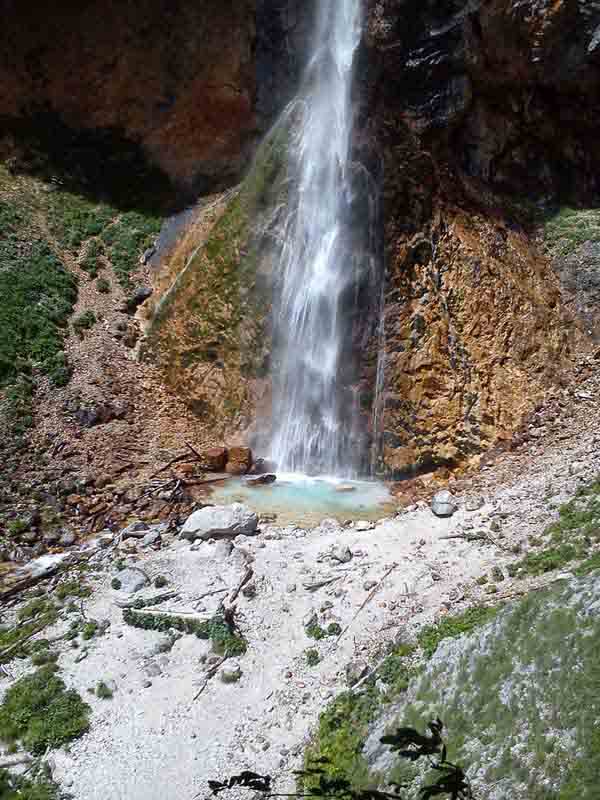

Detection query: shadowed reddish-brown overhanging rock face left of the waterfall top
(0, 0), (299, 198)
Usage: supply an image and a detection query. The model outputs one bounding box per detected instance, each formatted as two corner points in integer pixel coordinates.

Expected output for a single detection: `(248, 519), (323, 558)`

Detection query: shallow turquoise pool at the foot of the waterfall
(204, 473), (396, 527)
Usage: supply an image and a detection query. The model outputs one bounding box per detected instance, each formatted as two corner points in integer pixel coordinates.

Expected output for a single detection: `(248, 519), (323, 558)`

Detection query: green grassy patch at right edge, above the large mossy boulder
(516, 478), (600, 575)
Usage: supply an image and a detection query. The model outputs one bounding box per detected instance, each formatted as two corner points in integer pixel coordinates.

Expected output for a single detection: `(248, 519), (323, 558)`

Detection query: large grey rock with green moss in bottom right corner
(360, 577), (600, 800)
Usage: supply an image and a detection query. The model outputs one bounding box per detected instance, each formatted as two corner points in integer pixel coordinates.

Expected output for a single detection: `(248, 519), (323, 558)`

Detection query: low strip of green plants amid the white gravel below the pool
(123, 608), (248, 658)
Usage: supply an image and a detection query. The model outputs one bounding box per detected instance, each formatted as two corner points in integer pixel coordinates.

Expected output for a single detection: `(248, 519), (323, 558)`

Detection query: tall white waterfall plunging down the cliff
(271, 0), (362, 475)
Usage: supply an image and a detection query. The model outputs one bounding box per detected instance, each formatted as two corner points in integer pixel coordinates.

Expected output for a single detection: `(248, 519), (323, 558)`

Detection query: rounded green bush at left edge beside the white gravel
(0, 665), (90, 755)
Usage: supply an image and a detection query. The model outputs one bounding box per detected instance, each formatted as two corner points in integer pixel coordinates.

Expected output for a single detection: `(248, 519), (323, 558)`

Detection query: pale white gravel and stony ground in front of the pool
(2, 358), (600, 800)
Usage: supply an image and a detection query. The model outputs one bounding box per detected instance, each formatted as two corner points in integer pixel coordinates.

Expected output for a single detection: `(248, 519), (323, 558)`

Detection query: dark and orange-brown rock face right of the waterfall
(360, 0), (600, 476)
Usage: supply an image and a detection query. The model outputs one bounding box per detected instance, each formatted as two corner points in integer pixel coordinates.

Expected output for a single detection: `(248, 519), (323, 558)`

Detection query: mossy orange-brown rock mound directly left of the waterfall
(142, 121), (287, 426)
